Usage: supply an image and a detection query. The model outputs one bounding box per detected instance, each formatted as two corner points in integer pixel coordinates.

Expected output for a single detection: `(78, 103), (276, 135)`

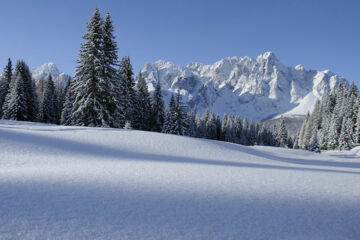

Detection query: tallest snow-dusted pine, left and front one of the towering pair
(71, 8), (116, 127)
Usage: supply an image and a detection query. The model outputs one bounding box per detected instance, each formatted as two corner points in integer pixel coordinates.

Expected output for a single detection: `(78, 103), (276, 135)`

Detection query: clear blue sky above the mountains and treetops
(0, 0), (360, 85)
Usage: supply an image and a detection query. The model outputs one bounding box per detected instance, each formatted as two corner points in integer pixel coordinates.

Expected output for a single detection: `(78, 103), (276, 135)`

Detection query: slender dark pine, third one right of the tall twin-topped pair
(151, 82), (165, 132)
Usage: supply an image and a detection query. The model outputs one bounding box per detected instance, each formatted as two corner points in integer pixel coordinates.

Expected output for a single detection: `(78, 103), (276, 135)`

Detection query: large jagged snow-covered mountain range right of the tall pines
(141, 52), (346, 120)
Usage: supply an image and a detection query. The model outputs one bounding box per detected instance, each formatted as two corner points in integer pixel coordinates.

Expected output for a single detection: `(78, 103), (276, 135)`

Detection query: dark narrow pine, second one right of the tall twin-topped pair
(133, 72), (151, 130)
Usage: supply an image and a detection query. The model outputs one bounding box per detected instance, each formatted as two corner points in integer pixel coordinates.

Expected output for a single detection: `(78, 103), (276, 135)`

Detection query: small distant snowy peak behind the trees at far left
(31, 62), (70, 88)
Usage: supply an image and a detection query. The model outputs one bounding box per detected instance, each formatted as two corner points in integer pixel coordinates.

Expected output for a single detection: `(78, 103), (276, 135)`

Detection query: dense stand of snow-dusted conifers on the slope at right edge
(294, 82), (360, 151)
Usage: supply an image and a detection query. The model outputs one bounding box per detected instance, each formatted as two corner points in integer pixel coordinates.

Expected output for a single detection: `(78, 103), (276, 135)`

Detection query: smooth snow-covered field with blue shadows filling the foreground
(0, 121), (360, 240)
